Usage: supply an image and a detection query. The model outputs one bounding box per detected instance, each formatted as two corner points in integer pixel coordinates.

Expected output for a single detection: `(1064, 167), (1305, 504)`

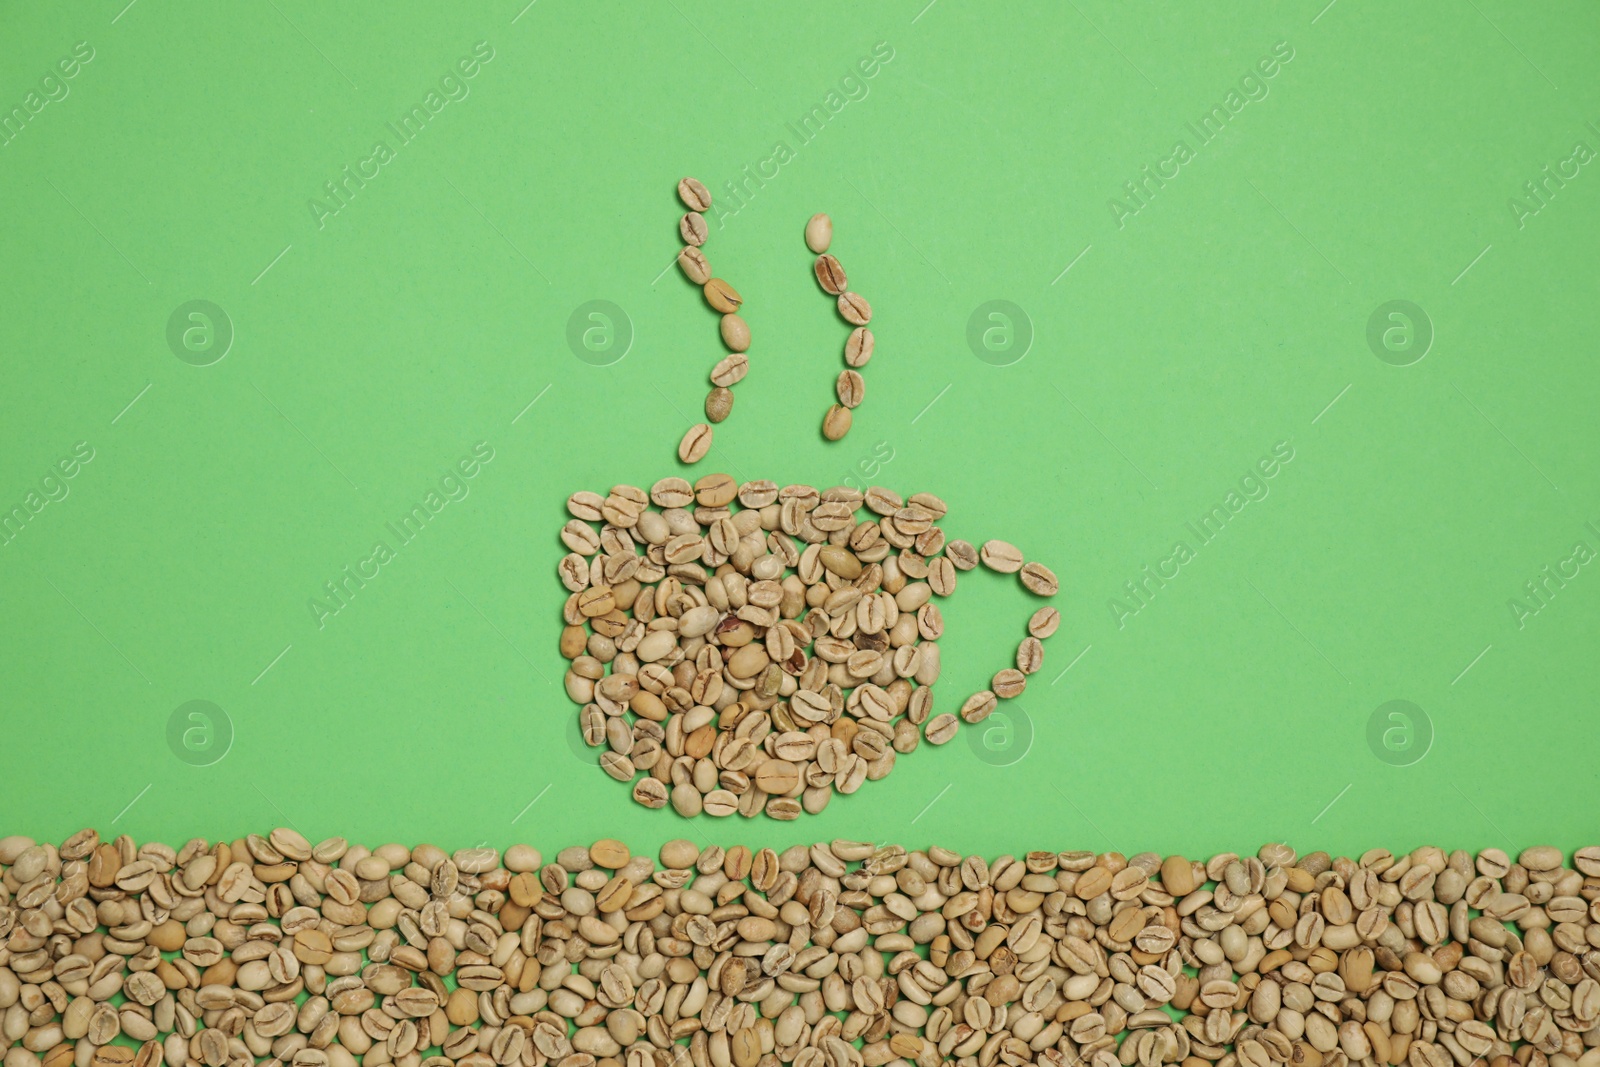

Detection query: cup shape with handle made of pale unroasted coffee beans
(558, 474), (1061, 819)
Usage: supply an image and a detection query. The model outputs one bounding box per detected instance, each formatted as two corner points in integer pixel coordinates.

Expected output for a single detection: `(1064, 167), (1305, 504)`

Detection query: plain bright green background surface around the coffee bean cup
(0, 0), (1600, 854)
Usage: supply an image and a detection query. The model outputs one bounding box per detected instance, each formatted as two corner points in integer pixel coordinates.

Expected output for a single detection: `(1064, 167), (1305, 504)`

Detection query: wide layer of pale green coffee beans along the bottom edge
(0, 829), (1600, 1067)
